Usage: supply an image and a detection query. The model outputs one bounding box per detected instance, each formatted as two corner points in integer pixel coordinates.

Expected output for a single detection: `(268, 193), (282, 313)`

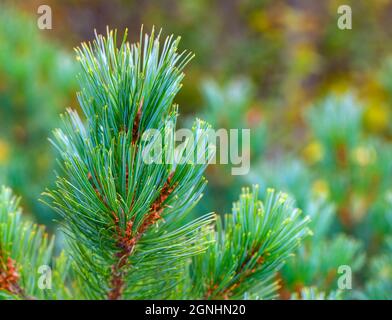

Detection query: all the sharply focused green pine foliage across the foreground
(0, 31), (309, 299)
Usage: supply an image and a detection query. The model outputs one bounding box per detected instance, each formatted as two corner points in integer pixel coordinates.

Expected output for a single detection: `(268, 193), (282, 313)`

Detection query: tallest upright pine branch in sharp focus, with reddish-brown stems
(48, 31), (214, 299)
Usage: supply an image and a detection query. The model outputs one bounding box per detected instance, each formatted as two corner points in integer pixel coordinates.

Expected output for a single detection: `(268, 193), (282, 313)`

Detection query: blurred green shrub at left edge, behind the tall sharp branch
(0, 6), (76, 222)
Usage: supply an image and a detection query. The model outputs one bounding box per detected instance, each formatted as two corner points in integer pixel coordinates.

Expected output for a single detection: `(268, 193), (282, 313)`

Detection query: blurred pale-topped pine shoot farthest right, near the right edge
(305, 95), (392, 228)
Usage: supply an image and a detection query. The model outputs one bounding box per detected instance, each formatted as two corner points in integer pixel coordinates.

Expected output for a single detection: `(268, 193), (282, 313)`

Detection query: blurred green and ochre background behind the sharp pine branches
(0, 0), (392, 299)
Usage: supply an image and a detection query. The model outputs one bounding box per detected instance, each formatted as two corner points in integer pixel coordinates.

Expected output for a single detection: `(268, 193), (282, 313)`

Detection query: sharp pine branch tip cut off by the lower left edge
(0, 187), (68, 299)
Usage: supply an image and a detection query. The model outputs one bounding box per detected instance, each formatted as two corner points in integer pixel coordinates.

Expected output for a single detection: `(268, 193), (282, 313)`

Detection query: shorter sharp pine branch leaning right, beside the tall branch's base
(189, 186), (309, 299)
